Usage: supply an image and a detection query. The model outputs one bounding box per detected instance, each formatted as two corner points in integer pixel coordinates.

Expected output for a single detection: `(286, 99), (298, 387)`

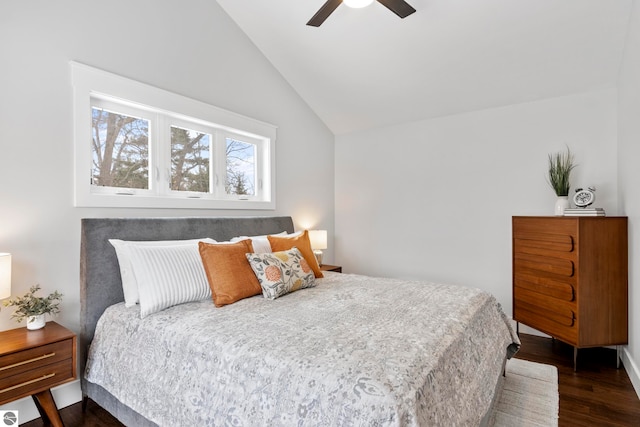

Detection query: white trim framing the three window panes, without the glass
(70, 61), (277, 209)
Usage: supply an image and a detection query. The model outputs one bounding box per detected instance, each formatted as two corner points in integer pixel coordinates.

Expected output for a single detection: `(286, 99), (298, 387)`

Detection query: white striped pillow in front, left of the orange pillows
(129, 243), (211, 317)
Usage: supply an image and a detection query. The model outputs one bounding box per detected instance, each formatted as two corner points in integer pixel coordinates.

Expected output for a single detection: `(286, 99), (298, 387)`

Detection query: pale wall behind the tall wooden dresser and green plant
(336, 89), (617, 314)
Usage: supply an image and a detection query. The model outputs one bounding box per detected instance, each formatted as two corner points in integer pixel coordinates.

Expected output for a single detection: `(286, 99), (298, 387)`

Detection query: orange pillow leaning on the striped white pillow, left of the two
(198, 240), (262, 307)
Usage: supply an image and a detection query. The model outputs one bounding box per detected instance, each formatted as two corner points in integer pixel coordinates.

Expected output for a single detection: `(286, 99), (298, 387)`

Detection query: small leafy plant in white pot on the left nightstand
(3, 285), (62, 330)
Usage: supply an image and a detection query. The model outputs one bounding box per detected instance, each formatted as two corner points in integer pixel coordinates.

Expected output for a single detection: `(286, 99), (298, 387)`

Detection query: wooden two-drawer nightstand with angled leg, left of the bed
(0, 322), (76, 427)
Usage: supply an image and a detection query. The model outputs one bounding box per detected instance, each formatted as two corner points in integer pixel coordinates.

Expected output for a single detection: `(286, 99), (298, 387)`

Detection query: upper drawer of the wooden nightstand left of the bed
(0, 338), (73, 380)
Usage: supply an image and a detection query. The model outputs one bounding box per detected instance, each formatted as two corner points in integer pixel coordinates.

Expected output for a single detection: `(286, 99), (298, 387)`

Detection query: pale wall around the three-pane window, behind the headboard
(0, 0), (334, 420)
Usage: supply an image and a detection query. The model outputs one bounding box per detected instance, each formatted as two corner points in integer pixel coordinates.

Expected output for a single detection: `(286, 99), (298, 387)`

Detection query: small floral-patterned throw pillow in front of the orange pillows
(247, 247), (316, 299)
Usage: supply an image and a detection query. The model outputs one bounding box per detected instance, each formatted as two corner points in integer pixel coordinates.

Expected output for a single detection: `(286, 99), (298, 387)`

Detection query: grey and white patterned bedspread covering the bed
(86, 273), (518, 426)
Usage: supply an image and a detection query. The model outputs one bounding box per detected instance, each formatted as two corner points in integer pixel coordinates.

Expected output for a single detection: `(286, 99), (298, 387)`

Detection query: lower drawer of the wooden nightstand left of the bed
(0, 360), (73, 404)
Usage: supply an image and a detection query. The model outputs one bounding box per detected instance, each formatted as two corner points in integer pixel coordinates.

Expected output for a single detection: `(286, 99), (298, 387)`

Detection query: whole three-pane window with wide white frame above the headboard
(71, 62), (276, 209)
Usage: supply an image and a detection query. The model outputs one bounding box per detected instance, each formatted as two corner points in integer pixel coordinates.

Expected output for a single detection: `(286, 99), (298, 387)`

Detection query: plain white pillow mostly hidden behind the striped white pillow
(109, 238), (216, 307)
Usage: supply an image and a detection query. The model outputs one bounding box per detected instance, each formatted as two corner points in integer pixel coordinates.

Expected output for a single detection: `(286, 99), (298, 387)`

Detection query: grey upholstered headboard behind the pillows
(79, 217), (294, 375)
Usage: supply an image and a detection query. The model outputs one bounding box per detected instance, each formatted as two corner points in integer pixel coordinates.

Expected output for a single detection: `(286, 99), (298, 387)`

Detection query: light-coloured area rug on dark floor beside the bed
(489, 359), (559, 427)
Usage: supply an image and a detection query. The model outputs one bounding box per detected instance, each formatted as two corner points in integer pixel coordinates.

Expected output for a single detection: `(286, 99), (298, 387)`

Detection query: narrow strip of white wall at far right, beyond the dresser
(618, 0), (640, 395)
